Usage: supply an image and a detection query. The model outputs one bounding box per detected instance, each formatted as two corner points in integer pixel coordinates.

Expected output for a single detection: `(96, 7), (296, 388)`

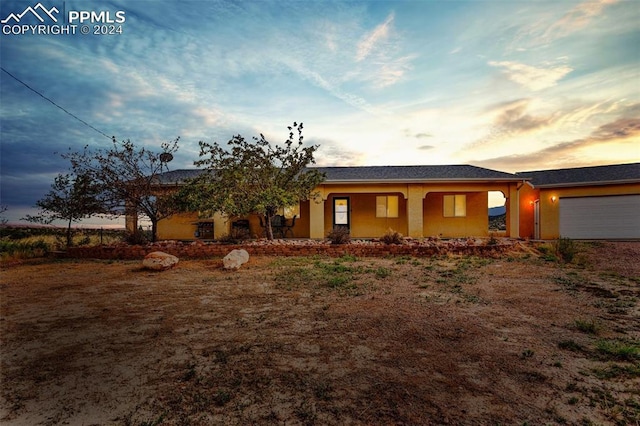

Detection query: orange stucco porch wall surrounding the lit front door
(324, 192), (407, 238)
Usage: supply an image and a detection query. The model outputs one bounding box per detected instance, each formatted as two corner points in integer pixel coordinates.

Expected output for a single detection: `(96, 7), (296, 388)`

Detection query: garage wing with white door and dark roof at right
(516, 163), (640, 240)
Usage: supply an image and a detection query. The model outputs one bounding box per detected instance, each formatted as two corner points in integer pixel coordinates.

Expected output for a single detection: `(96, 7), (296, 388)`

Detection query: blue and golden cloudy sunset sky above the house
(0, 0), (640, 226)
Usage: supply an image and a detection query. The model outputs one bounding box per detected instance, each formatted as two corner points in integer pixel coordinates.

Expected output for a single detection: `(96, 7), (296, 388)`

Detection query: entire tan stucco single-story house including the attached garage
(141, 163), (640, 240)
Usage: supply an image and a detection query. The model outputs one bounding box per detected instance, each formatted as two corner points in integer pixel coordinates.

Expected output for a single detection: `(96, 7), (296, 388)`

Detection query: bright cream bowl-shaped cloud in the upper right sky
(489, 61), (573, 92)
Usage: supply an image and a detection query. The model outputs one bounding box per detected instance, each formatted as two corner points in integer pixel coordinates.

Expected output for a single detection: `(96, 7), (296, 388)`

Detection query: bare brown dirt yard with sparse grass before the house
(0, 242), (640, 425)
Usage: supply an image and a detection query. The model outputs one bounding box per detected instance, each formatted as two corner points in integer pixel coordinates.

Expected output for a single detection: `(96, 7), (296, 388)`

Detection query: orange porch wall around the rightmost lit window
(423, 192), (489, 238)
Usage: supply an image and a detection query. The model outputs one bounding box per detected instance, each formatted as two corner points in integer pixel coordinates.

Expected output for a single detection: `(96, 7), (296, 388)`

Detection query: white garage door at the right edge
(560, 195), (640, 239)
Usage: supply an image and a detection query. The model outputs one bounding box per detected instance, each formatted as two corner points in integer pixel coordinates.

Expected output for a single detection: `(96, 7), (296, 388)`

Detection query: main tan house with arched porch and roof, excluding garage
(150, 165), (529, 240)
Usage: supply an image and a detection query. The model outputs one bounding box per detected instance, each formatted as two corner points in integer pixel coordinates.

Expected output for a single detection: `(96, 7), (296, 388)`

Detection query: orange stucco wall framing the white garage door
(540, 184), (640, 240)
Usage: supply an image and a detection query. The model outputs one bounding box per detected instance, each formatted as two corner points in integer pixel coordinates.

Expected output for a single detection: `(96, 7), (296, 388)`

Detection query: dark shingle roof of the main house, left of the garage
(159, 165), (523, 185)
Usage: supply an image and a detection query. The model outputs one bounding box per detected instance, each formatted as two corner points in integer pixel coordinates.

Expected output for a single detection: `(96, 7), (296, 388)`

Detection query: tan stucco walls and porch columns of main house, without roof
(158, 183), (520, 240)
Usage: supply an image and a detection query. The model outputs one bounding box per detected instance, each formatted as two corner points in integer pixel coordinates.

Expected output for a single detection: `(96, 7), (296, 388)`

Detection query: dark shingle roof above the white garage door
(516, 163), (640, 187)
